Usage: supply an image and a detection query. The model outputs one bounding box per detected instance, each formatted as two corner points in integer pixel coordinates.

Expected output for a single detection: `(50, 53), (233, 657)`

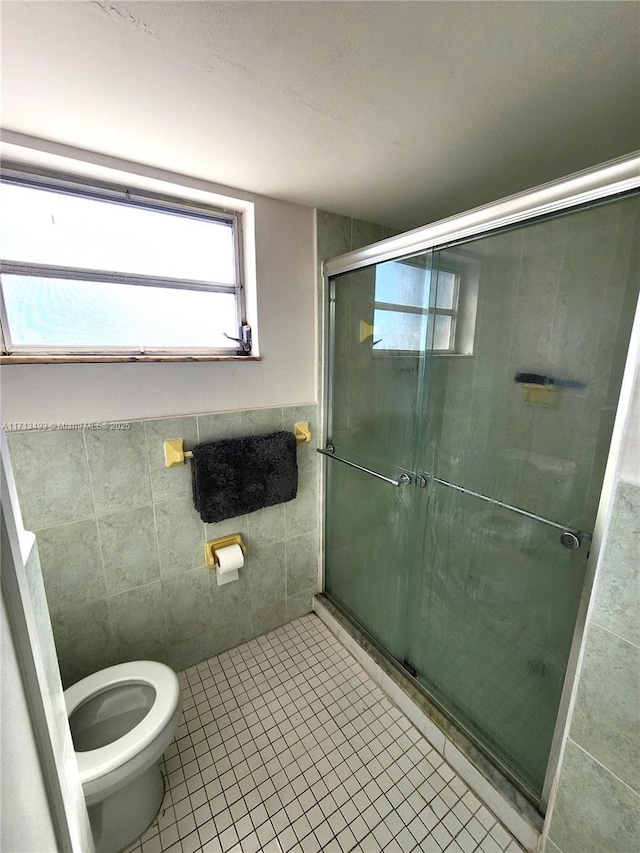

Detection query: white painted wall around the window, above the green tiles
(0, 141), (317, 423)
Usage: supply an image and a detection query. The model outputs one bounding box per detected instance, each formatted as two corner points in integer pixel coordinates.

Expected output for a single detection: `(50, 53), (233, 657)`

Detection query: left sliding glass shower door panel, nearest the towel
(325, 253), (430, 662)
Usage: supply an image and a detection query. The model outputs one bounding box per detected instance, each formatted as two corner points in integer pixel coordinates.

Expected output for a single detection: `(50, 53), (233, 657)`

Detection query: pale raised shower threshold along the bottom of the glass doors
(314, 593), (544, 849)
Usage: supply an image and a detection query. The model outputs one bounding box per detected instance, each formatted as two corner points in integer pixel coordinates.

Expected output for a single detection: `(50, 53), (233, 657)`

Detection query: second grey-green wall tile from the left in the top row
(85, 423), (151, 515)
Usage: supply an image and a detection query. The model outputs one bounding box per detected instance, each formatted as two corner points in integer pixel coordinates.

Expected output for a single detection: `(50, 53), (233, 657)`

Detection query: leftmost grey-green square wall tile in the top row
(9, 430), (93, 530)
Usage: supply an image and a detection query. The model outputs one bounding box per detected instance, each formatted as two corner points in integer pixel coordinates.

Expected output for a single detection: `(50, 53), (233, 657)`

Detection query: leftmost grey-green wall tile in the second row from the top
(37, 519), (107, 613)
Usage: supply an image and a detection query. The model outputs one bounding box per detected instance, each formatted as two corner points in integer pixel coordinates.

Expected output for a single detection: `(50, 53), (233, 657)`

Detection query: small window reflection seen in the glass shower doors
(373, 254), (464, 354)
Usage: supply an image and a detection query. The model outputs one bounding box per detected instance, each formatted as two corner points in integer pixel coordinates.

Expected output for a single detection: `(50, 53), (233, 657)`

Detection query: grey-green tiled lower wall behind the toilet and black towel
(9, 405), (319, 686)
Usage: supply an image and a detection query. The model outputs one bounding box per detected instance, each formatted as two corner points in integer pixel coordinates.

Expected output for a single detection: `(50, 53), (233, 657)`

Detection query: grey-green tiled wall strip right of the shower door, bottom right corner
(545, 480), (640, 853)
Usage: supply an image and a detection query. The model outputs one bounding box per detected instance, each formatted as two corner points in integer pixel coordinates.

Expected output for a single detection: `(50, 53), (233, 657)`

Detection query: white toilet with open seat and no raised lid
(64, 661), (180, 853)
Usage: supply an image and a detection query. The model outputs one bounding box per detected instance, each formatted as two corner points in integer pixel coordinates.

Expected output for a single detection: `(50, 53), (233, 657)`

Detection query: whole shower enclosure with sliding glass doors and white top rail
(319, 159), (640, 813)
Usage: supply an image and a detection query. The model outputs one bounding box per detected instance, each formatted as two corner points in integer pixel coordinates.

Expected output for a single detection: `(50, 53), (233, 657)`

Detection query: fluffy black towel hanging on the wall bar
(192, 432), (298, 522)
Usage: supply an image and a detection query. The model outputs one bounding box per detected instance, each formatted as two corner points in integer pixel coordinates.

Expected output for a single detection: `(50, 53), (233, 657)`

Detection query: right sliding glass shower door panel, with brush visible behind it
(406, 197), (638, 799)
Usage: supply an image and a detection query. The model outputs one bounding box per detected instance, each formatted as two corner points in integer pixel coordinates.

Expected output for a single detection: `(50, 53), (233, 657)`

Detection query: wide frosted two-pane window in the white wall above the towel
(0, 168), (251, 360)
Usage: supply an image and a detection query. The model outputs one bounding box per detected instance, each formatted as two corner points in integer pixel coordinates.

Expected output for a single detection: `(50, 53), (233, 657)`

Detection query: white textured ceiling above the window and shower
(1, 0), (640, 228)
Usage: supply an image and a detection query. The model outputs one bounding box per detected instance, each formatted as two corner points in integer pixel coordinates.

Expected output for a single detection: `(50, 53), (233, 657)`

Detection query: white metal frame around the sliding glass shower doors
(320, 152), (640, 813)
